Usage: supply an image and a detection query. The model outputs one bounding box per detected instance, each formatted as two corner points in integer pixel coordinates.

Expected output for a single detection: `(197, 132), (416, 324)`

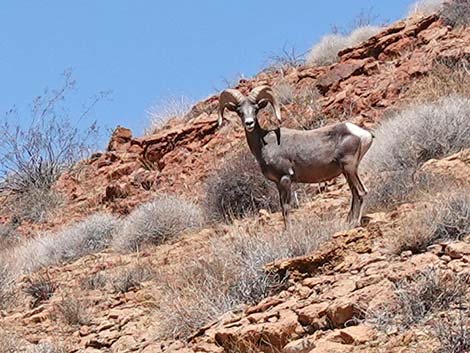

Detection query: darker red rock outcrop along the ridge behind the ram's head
(50, 15), (470, 221)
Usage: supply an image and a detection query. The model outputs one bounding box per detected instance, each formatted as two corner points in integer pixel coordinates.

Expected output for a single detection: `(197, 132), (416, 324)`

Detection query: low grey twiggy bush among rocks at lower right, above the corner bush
(368, 268), (469, 331)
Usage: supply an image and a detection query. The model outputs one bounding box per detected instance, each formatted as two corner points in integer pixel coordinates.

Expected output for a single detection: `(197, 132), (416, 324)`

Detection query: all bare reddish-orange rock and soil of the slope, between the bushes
(0, 11), (470, 353)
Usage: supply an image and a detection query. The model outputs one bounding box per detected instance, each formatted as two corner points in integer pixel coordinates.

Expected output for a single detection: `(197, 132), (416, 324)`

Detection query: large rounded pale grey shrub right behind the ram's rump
(362, 96), (470, 209)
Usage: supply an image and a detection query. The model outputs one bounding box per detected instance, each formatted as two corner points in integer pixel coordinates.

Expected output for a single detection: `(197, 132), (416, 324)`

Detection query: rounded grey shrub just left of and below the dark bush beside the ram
(113, 195), (204, 251)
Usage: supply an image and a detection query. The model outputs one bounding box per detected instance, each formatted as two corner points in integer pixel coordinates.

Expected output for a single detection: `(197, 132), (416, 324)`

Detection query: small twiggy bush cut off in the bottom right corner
(434, 308), (470, 353)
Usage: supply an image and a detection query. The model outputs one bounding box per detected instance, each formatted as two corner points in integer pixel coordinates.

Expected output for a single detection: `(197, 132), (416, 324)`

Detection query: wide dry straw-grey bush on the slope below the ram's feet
(159, 217), (345, 337)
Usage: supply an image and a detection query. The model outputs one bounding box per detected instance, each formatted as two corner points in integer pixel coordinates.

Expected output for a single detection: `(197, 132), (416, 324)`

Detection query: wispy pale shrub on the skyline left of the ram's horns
(144, 96), (194, 135)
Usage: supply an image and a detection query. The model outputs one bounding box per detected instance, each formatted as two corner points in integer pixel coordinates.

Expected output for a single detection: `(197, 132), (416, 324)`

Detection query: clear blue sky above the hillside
(0, 0), (412, 143)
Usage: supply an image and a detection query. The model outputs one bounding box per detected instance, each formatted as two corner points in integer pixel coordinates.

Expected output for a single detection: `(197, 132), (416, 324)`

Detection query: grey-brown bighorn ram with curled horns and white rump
(218, 86), (373, 226)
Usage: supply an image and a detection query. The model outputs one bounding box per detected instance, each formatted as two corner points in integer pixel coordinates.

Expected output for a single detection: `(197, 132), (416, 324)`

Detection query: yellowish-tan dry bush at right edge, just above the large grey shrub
(402, 59), (470, 103)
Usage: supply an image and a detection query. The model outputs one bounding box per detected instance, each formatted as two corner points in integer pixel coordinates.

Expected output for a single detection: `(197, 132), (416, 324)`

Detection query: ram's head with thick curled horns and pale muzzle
(218, 86), (281, 132)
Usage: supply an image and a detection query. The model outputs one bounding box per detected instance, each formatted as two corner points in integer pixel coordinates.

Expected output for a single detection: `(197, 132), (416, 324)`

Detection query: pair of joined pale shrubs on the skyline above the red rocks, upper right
(306, 25), (382, 66)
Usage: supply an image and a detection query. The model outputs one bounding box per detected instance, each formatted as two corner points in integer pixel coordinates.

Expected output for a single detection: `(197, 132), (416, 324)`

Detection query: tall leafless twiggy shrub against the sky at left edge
(0, 71), (102, 193)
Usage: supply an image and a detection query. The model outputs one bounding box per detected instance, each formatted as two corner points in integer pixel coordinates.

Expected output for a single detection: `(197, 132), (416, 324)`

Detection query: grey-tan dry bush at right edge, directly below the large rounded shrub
(390, 187), (470, 254)
